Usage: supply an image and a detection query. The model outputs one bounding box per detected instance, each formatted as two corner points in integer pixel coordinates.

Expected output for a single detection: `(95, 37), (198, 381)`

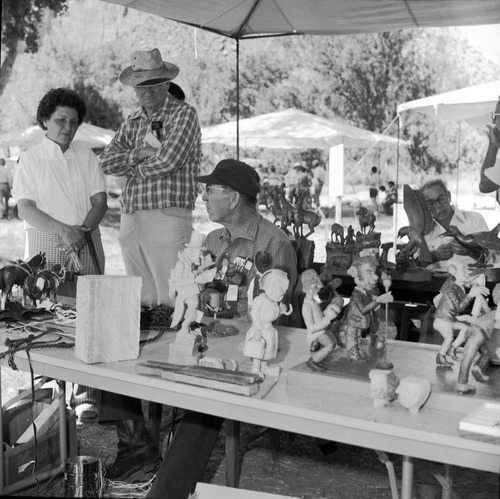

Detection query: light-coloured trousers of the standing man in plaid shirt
(119, 208), (193, 308)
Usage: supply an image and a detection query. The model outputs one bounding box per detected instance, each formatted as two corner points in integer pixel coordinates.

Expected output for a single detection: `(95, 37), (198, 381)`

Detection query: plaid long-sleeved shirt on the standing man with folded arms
(99, 95), (201, 213)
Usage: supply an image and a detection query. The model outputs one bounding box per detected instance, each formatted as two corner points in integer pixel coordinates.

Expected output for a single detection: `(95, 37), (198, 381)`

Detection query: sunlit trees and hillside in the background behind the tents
(0, 0), (500, 183)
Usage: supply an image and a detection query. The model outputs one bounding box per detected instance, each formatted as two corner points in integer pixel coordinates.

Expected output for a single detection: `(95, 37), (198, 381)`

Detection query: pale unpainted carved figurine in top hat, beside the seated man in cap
(169, 232), (216, 336)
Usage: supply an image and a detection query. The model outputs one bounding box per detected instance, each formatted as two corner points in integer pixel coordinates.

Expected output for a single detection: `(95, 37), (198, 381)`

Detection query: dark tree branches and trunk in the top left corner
(0, 0), (67, 95)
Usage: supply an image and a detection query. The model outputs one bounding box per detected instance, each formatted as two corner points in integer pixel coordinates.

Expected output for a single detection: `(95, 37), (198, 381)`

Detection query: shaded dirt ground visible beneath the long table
(4, 386), (499, 499)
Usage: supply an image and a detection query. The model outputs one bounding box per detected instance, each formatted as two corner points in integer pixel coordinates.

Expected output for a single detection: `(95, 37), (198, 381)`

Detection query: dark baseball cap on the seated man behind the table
(195, 159), (260, 197)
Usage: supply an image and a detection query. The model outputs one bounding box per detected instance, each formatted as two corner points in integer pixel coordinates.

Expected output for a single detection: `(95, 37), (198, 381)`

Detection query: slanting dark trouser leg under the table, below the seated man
(146, 411), (224, 499)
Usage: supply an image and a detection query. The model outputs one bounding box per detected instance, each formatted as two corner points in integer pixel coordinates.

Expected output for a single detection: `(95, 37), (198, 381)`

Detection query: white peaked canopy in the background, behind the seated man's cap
(202, 108), (404, 149)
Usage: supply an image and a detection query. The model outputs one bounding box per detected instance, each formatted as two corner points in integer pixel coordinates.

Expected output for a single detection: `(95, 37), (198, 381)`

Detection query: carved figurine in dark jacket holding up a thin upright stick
(340, 256), (394, 362)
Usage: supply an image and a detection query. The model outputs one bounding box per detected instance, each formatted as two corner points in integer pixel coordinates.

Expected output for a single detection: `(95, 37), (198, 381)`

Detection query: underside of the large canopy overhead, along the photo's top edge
(101, 0), (500, 39)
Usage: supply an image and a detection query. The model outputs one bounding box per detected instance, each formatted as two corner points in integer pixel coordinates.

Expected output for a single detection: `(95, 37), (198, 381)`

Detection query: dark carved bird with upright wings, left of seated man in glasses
(398, 184), (434, 267)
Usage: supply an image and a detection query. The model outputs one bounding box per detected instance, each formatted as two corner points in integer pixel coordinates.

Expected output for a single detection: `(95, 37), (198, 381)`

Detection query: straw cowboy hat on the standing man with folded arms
(120, 49), (179, 87)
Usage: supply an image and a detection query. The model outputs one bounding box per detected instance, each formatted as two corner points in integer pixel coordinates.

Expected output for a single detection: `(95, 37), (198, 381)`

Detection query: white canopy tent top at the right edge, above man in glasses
(397, 80), (500, 126)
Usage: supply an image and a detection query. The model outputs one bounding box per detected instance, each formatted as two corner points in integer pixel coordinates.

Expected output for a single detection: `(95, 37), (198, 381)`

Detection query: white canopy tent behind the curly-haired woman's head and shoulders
(0, 123), (115, 149)
